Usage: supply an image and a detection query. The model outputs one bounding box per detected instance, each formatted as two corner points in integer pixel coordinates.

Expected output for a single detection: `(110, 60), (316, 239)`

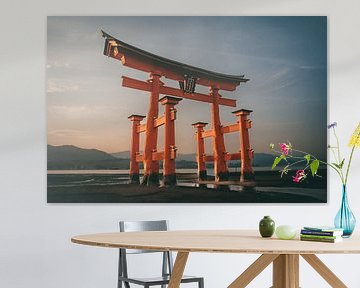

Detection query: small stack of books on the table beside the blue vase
(300, 227), (344, 243)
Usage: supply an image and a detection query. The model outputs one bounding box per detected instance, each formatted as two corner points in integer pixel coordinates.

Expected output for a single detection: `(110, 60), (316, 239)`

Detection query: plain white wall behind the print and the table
(0, 0), (360, 288)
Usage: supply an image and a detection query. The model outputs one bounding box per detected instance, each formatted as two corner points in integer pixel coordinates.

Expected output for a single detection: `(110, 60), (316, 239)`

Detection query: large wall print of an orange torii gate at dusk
(46, 16), (327, 203)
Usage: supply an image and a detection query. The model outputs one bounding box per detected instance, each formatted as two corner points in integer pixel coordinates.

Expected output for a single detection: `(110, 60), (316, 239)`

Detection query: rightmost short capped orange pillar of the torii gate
(233, 109), (255, 181)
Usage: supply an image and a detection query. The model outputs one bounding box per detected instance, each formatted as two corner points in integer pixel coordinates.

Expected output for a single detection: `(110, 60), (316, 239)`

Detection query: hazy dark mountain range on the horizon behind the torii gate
(47, 145), (274, 170)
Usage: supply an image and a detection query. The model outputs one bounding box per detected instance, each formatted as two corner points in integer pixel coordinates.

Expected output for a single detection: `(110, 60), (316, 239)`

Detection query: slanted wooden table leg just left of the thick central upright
(228, 254), (279, 288)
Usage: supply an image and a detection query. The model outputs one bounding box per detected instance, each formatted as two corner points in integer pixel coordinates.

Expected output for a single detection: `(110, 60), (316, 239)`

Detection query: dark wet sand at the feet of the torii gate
(48, 171), (327, 203)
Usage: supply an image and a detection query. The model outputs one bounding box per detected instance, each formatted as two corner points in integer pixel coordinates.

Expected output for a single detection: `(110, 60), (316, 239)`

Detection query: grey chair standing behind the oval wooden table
(118, 220), (204, 288)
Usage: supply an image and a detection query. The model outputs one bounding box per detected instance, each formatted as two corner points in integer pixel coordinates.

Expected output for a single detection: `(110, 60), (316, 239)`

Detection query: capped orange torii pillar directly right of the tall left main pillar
(159, 96), (182, 186)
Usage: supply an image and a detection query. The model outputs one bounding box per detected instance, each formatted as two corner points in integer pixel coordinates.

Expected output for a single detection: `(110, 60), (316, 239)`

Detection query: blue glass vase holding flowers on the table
(334, 185), (356, 237)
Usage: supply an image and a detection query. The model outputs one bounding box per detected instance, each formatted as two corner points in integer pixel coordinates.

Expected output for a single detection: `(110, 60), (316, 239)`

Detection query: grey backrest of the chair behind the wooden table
(119, 220), (169, 254)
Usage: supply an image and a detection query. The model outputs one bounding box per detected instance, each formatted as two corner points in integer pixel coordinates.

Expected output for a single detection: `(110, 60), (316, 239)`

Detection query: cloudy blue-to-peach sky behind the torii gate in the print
(46, 16), (327, 157)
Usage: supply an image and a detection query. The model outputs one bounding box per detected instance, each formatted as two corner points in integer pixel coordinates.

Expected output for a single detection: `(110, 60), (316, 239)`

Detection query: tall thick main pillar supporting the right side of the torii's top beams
(210, 87), (229, 182)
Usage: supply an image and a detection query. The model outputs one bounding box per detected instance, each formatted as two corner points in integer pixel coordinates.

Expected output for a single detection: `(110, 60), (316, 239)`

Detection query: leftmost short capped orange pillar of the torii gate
(128, 114), (145, 183)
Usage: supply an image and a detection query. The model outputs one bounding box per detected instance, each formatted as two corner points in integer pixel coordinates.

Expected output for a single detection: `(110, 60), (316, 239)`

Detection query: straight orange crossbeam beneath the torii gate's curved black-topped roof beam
(122, 76), (236, 107)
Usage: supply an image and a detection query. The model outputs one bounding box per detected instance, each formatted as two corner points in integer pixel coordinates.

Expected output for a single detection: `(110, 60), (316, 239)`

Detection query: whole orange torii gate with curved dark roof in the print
(102, 31), (253, 185)
